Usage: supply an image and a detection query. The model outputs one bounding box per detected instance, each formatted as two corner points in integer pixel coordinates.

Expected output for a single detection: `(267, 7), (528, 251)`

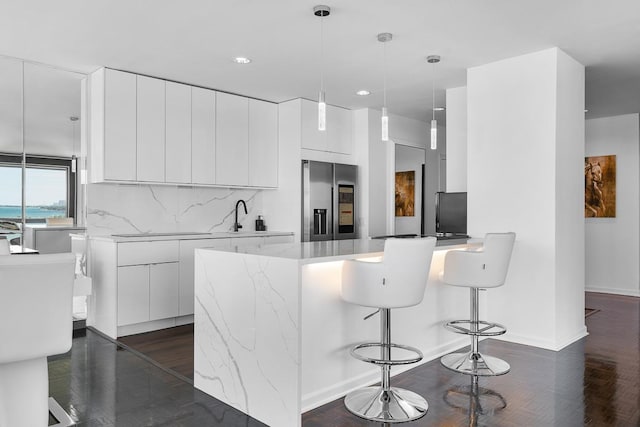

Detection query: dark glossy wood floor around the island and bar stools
(49, 293), (640, 427)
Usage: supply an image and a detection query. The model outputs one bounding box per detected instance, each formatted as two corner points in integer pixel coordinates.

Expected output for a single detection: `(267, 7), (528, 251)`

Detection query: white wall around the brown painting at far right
(585, 114), (640, 296)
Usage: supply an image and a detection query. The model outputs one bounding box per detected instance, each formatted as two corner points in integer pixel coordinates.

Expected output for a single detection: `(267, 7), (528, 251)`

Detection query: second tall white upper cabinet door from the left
(136, 76), (165, 182)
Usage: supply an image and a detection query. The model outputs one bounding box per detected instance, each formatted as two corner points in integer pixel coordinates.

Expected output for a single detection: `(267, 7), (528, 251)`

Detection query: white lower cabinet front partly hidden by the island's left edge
(178, 239), (230, 316)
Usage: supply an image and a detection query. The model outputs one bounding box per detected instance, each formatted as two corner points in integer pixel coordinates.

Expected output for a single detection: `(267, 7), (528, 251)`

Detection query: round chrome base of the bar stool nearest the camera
(344, 387), (429, 423)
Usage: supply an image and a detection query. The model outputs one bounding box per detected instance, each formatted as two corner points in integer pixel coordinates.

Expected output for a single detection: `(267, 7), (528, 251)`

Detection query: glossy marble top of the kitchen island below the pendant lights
(199, 239), (476, 264)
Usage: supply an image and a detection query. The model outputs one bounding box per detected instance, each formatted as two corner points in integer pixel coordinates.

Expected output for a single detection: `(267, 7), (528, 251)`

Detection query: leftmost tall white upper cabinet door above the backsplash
(105, 69), (137, 181)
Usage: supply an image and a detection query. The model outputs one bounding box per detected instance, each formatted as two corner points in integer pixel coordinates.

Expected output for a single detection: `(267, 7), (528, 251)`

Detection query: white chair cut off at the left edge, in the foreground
(0, 253), (75, 427)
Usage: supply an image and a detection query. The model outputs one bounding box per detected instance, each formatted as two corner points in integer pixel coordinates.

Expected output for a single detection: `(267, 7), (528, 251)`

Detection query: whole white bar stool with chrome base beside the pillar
(440, 233), (516, 376)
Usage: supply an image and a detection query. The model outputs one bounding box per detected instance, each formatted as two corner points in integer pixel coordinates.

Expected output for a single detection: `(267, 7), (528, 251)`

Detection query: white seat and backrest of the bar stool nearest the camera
(342, 237), (436, 308)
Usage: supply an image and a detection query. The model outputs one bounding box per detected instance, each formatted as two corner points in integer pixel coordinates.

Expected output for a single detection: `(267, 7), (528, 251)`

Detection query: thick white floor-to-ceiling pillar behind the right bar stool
(467, 48), (585, 350)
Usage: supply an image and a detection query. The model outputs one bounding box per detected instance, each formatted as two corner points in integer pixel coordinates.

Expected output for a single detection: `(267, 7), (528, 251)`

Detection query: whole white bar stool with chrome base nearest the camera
(342, 237), (436, 422)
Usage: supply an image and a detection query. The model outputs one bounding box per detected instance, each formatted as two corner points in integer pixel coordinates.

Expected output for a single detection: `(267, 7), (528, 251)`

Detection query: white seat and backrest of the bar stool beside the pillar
(442, 232), (516, 288)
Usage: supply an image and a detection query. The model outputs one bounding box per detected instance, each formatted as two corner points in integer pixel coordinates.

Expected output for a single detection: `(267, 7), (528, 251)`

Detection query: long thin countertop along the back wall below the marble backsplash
(88, 231), (293, 243)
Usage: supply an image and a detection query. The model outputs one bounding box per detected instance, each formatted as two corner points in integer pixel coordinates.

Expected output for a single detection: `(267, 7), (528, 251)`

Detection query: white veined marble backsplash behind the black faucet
(86, 184), (262, 235)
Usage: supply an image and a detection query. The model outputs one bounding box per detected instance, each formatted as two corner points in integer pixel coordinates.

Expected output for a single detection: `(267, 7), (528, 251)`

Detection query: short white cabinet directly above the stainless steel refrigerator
(301, 99), (353, 154)
